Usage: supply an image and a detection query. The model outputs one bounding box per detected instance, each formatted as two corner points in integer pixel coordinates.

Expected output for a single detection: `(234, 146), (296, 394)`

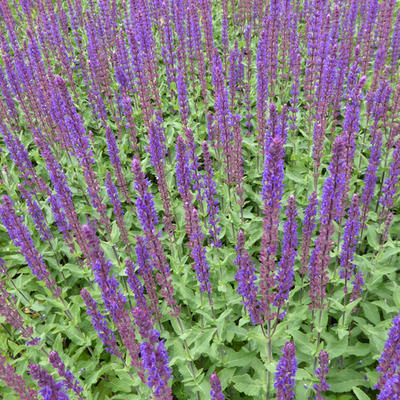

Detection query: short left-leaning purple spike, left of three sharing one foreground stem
(234, 230), (261, 325)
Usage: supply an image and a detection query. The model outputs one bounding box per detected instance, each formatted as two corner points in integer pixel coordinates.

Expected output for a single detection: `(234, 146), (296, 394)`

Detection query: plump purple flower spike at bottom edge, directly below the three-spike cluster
(274, 342), (297, 400)
